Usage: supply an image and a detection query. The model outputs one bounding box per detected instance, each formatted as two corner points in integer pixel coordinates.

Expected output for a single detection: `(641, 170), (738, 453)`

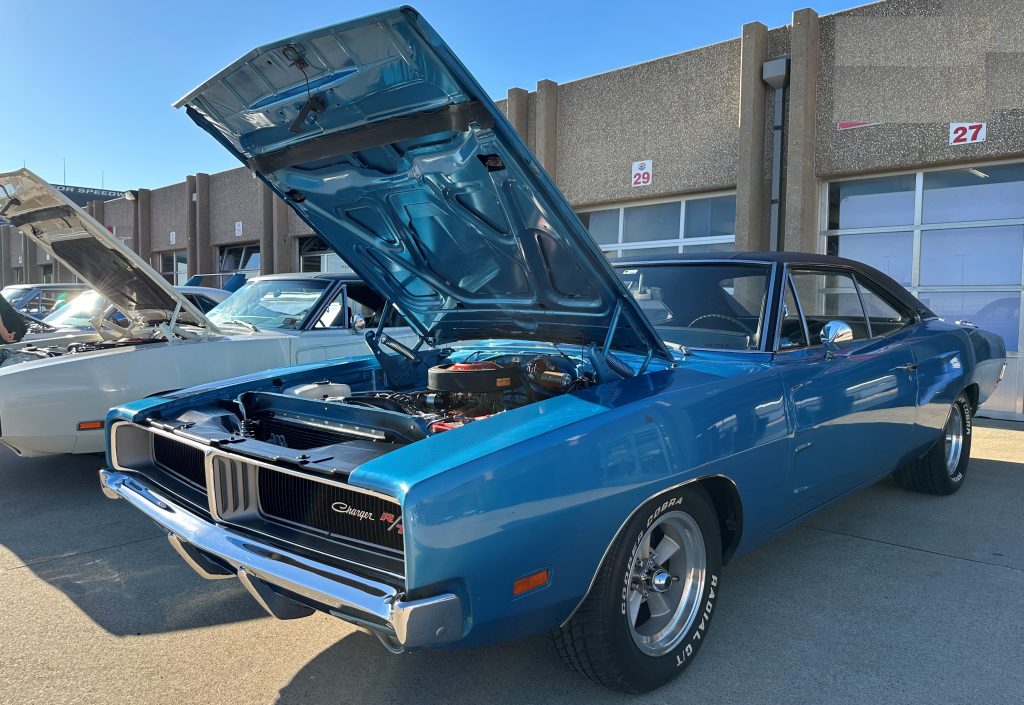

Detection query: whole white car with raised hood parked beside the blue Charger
(0, 169), (418, 456)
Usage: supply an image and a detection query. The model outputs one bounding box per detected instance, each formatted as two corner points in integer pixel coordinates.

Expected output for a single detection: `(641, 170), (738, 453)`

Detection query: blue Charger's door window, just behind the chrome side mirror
(793, 269), (869, 345)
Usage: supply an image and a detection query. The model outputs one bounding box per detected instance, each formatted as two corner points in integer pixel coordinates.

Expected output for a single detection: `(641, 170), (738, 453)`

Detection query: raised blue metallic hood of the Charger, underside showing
(176, 8), (671, 359)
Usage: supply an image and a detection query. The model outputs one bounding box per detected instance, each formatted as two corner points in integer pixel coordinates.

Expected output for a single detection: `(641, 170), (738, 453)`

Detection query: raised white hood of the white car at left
(0, 169), (218, 332)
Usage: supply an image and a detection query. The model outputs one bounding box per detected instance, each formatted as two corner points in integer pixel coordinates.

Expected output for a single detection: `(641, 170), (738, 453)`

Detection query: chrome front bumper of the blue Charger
(99, 469), (463, 651)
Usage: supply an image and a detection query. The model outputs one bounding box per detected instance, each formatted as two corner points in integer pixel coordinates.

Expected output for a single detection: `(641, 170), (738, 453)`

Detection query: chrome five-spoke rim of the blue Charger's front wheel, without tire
(626, 511), (708, 657)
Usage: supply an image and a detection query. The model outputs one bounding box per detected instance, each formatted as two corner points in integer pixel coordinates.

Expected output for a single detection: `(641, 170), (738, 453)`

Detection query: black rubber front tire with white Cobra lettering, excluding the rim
(552, 485), (722, 693)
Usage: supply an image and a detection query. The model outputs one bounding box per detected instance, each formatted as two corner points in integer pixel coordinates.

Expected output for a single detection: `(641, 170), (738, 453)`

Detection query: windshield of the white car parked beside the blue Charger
(207, 279), (328, 329)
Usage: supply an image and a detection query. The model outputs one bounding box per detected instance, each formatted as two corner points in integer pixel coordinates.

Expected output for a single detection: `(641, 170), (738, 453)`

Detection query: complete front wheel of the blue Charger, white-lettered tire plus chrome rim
(553, 486), (722, 693)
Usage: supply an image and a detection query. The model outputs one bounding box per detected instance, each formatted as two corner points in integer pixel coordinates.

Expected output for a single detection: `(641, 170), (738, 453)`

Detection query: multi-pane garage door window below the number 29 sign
(580, 194), (736, 257)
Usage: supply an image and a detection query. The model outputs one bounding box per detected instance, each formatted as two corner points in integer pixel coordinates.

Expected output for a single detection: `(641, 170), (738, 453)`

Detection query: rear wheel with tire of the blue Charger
(893, 391), (972, 495)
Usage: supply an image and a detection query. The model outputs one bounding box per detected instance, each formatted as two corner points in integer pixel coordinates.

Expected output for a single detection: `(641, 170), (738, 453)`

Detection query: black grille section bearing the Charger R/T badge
(259, 467), (403, 550)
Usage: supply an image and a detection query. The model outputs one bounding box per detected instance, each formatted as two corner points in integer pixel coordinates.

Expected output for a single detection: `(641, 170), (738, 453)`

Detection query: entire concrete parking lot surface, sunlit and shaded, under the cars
(0, 420), (1024, 705)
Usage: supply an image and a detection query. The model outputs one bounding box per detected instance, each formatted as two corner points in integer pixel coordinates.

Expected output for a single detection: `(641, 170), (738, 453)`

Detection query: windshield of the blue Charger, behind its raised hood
(616, 262), (771, 350)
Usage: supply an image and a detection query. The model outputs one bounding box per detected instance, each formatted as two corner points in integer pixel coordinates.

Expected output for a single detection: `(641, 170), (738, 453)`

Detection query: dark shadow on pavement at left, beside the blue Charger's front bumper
(0, 450), (265, 636)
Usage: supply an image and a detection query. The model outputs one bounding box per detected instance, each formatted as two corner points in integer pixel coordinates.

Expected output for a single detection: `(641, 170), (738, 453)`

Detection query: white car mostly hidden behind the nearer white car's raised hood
(0, 286), (231, 352)
